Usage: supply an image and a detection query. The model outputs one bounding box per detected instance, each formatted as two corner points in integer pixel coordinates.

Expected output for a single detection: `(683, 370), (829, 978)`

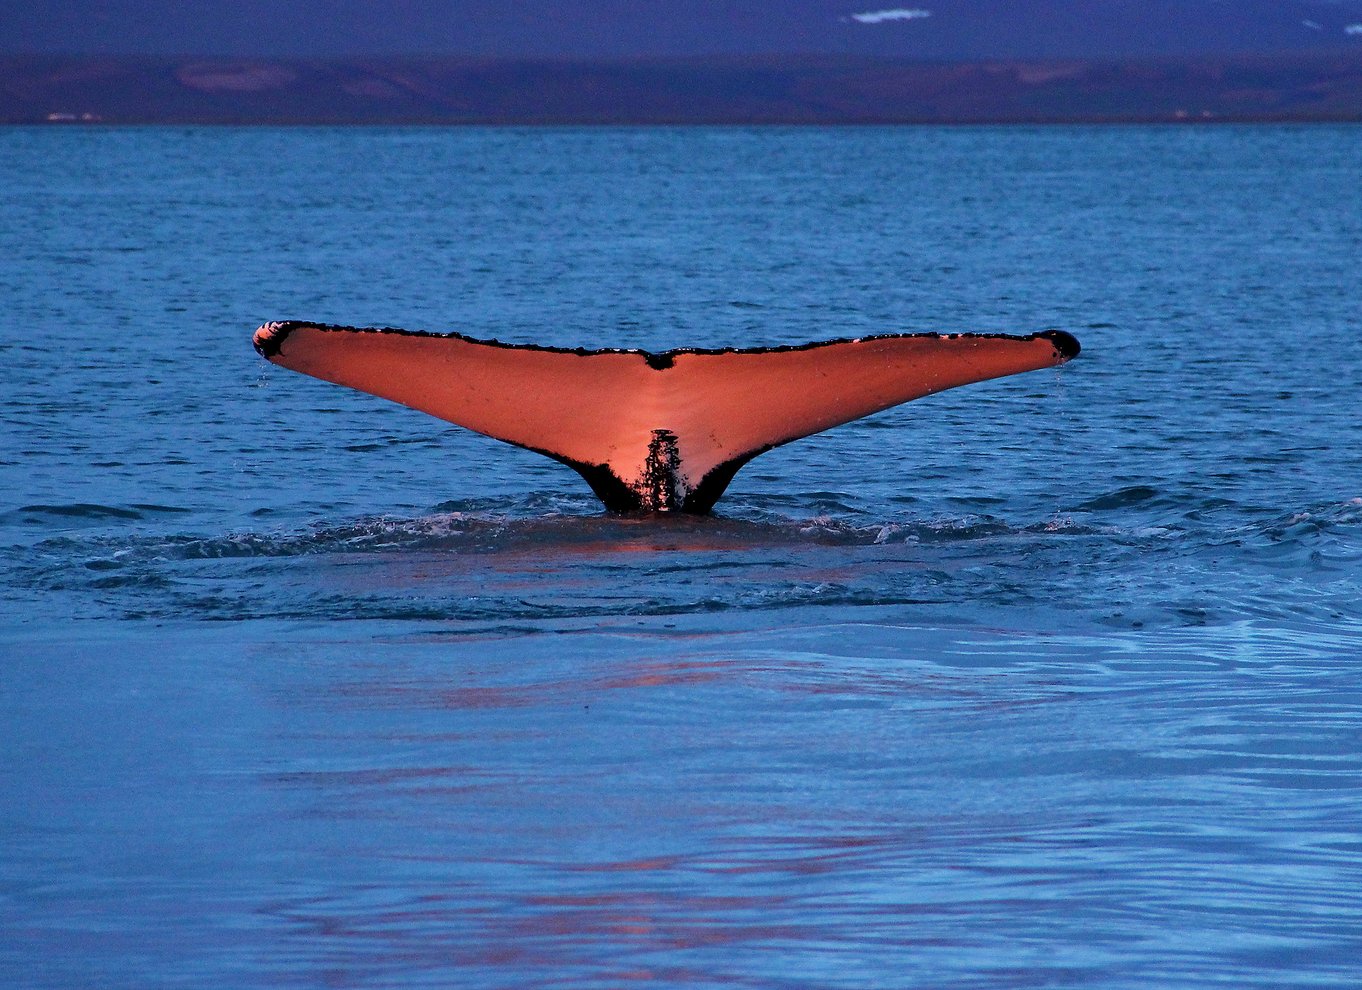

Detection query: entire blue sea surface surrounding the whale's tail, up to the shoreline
(0, 127), (1362, 987)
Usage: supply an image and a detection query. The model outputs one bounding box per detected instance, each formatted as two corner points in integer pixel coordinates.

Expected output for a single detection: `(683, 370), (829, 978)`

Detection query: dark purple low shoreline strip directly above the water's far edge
(8, 46), (1362, 125)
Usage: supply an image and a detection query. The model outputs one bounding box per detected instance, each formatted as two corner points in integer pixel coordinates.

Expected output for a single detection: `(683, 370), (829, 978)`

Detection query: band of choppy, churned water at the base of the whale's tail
(4, 494), (1362, 626)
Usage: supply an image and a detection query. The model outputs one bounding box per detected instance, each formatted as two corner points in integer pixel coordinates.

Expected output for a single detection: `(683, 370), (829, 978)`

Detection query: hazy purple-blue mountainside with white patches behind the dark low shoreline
(8, 0), (1362, 59)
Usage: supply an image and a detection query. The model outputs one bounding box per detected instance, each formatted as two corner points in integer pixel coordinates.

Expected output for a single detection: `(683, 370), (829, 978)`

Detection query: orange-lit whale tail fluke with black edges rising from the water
(255, 321), (1079, 512)
